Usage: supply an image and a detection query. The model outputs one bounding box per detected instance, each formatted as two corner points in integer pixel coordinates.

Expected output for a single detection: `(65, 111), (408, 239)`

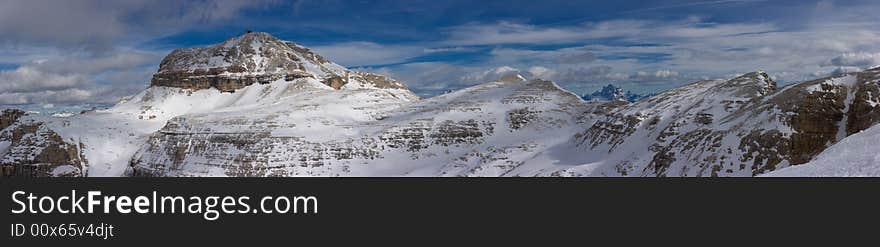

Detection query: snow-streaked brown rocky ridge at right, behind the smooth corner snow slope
(581, 69), (880, 176)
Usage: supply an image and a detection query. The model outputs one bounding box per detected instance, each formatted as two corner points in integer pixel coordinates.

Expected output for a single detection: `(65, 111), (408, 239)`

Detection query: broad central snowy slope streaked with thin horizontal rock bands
(132, 74), (600, 176)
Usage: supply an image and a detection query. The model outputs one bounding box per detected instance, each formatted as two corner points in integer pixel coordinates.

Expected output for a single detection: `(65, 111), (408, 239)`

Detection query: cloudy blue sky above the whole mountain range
(0, 0), (880, 105)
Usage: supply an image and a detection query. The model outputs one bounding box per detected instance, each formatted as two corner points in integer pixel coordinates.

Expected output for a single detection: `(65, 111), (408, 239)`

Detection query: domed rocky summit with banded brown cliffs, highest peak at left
(151, 32), (406, 92)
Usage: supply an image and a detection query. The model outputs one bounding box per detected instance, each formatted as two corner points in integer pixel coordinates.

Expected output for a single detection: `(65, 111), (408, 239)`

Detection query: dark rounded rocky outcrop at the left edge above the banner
(0, 121), (88, 177)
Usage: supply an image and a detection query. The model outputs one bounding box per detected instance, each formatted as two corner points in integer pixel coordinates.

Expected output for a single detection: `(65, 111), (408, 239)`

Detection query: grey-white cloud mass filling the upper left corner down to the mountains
(0, 0), (279, 104)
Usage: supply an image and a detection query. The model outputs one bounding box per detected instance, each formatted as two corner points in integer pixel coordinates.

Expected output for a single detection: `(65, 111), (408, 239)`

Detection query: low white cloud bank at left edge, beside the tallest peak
(0, 50), (161, 104)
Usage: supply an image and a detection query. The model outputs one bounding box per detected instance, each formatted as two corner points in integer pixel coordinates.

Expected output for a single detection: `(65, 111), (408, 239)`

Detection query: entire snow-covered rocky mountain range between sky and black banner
(0, 33), (880, 176)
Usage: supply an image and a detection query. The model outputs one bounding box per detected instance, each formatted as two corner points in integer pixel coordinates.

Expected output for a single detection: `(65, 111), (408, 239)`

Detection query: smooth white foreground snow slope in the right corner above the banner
(762, 126), (880, 177)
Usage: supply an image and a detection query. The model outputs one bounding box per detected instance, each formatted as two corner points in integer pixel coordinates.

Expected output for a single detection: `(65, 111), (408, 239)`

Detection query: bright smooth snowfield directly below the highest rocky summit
(27, 78), (418, 176)
